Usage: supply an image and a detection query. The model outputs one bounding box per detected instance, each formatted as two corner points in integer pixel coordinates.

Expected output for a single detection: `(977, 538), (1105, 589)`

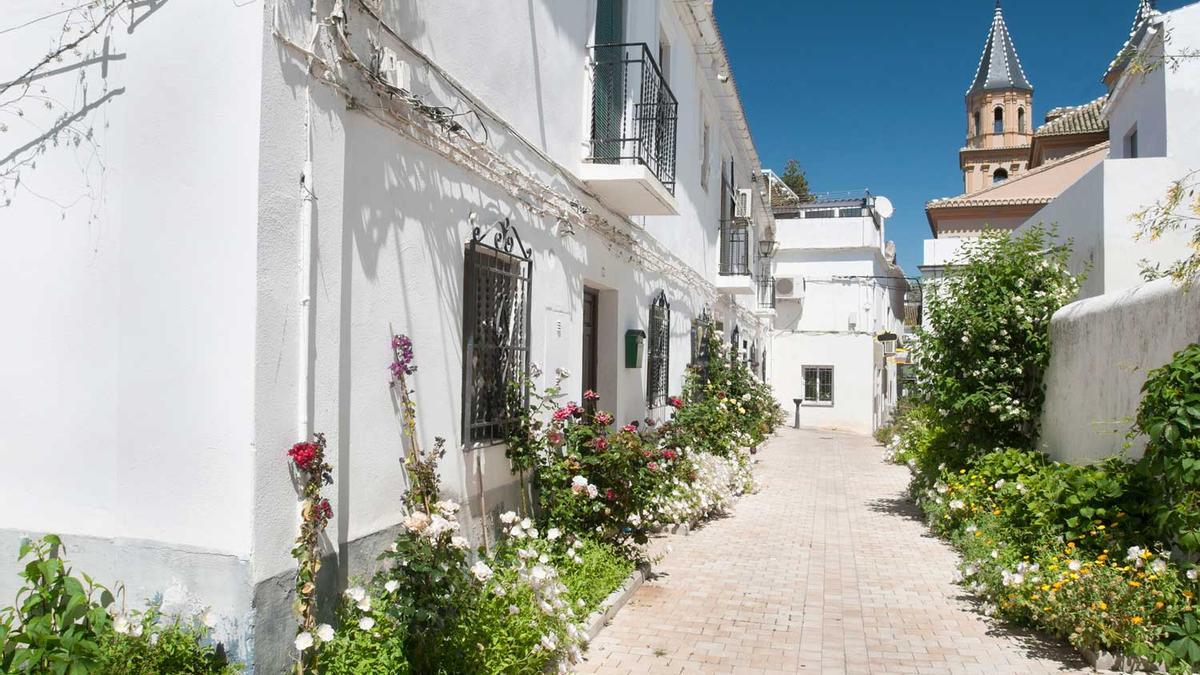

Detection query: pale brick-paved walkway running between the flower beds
(578, 429), (1085, 675)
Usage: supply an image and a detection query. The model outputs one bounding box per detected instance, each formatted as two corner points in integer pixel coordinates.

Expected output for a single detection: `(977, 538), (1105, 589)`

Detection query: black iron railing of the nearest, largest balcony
(588, 42), (679, 195)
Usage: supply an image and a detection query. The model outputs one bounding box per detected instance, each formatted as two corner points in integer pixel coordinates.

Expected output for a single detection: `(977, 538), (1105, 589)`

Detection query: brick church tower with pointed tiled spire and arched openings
(959, 0), (1033, 193)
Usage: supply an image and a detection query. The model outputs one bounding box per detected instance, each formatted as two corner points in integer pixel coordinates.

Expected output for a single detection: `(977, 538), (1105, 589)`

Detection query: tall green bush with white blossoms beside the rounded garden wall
(917, 227), (1079, 461)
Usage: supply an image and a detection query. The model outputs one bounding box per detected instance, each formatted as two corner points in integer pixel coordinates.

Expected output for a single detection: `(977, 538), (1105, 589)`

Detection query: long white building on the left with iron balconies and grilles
(0, 0), (777, 673)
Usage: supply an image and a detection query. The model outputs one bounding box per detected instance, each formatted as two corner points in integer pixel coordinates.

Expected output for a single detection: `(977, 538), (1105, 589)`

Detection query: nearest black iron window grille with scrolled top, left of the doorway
(462, 220), (533, 443)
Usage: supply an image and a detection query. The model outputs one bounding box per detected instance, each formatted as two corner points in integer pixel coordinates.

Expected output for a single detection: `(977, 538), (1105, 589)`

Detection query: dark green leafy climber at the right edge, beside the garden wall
(1134, 345), (1200, 552)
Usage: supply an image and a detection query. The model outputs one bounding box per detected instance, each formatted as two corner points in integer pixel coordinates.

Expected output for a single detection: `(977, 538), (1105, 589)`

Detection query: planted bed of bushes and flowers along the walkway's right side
(886, 228), (1200, 671)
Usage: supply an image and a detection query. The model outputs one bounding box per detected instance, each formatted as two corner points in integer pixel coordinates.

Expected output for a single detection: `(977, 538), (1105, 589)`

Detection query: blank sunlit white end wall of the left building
(0, 0), (263, 637)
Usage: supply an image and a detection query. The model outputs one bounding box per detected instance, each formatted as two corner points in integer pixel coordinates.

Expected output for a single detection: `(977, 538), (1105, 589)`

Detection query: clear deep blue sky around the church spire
(715, 0), (1189, 275)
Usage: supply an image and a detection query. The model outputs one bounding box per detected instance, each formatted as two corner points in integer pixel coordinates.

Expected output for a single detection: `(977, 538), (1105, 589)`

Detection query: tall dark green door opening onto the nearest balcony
(592, 0), (625, 163)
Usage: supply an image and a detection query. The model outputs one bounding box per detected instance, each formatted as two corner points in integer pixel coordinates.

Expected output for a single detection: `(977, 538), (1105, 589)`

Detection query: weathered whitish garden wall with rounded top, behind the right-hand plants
(1039, 280), (1200, 462)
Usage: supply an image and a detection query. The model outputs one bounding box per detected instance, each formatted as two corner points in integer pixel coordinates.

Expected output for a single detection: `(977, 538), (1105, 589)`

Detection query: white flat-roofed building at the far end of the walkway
(768, 193), (907, 432)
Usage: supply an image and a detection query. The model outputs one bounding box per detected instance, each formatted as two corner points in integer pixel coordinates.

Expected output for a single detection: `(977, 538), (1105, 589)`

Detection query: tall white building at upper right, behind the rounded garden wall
(1021, 0), (1200, 298)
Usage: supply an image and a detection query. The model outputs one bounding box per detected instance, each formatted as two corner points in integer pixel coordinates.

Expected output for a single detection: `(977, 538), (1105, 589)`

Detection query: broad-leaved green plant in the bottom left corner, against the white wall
(0, 534), (114, 675)
